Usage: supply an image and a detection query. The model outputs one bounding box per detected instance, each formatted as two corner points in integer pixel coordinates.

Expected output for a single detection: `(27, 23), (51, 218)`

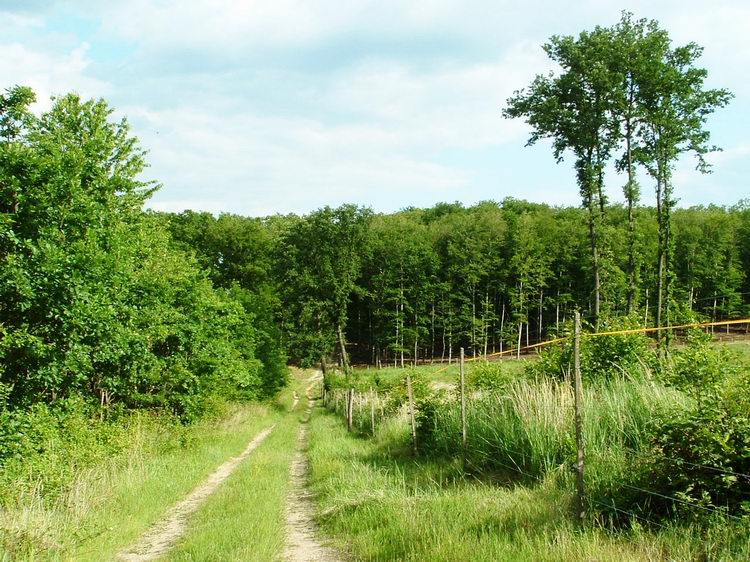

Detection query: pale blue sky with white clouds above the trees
(0, 0), (750, 216)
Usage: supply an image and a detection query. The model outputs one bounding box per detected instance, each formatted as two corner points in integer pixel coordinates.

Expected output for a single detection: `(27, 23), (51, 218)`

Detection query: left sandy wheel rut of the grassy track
(117, 424), (275, 562)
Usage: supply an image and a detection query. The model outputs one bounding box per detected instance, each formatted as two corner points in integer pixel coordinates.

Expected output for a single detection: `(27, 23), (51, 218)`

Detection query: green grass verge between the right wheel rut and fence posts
(309, 398), (750, 562)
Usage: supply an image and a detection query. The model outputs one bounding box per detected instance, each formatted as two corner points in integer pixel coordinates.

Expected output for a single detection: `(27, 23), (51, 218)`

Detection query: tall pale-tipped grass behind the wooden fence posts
(420, 377), (684, 487)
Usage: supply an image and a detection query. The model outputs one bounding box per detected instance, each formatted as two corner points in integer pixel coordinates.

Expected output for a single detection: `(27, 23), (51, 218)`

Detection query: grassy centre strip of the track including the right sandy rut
(166, 371), (344, 562)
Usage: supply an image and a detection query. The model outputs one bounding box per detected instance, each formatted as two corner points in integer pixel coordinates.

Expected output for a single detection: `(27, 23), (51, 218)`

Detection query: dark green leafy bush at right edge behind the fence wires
(641, 332), (750, 518)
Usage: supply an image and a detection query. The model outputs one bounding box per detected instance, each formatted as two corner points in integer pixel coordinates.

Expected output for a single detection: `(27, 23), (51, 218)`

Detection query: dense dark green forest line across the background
(166, 198), (750, 367)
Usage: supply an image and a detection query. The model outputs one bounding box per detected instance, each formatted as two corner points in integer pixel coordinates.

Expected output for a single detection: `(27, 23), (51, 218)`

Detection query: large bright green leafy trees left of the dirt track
(0, 88), (284, 426)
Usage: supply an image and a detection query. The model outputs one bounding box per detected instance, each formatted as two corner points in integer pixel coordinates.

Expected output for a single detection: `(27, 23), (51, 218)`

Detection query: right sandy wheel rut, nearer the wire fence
(284, 377), (344, 562)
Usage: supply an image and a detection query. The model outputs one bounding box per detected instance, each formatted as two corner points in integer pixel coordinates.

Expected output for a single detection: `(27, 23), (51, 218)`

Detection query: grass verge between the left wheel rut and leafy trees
(0, 389), (291, 561)
